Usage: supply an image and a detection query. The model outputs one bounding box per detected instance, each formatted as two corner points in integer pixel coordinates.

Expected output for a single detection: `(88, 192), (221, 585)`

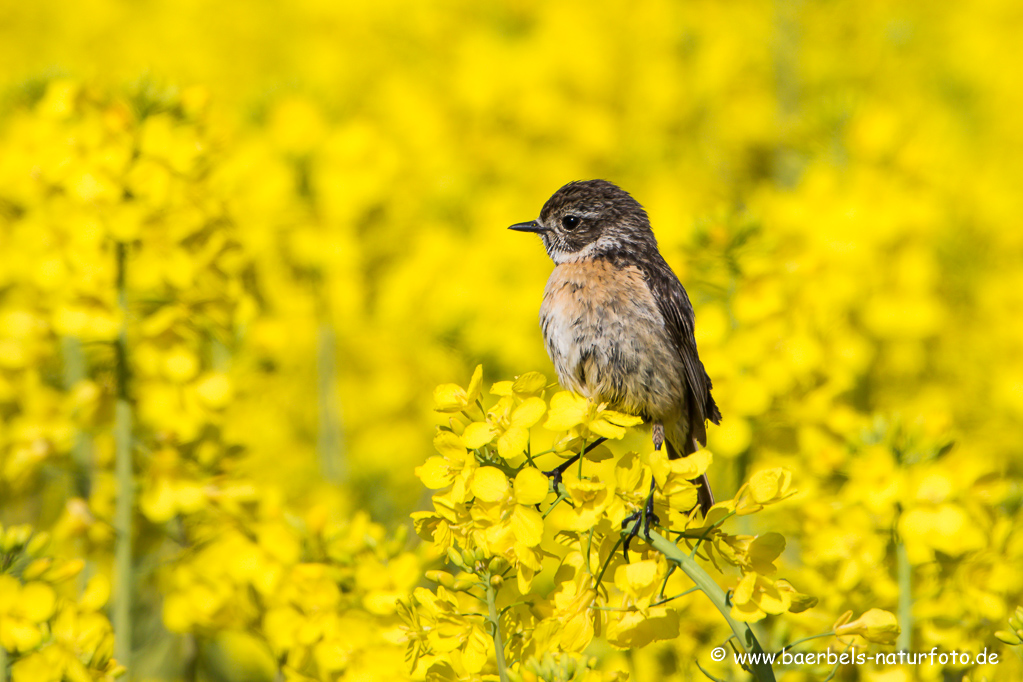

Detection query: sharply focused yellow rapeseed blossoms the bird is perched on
(402, 366), (845, 679)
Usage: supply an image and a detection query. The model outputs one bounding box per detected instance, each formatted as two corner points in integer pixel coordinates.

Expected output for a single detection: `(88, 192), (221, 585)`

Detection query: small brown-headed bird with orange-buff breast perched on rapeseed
(508, 180), (721, 514)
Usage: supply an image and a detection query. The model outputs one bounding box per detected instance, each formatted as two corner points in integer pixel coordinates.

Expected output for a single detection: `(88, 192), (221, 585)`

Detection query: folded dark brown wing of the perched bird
(637, 254), (721, 456)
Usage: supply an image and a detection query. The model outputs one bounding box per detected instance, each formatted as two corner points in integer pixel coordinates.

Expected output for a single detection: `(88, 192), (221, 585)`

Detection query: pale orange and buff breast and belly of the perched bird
(540, 259), (683, 419)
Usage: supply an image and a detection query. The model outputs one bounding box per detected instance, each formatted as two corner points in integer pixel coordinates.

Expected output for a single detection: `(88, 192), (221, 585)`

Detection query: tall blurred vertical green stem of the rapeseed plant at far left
(114, 242), (135, 676)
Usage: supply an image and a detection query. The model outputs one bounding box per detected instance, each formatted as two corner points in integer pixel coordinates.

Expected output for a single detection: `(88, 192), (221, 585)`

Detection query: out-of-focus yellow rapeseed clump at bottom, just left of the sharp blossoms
(163, 504), (421, 680)
